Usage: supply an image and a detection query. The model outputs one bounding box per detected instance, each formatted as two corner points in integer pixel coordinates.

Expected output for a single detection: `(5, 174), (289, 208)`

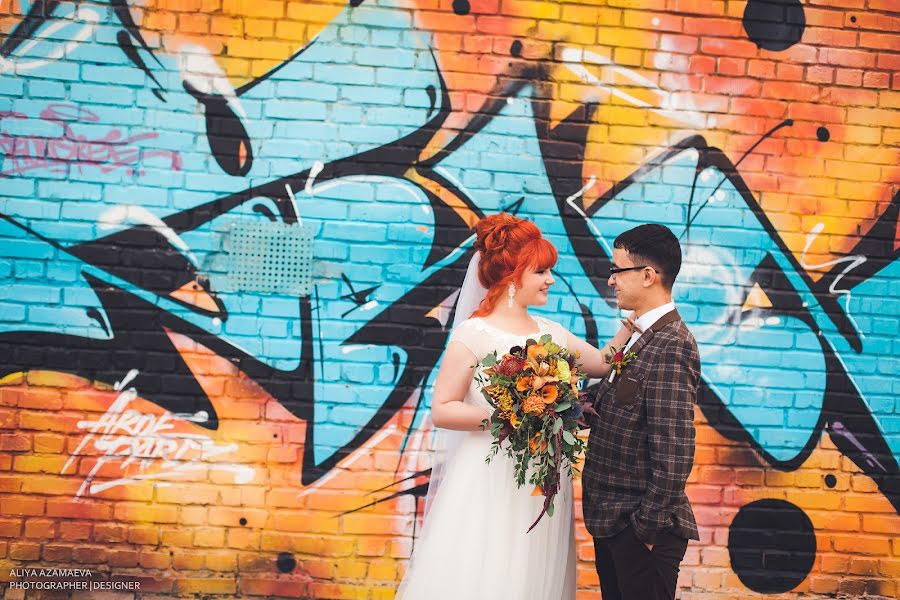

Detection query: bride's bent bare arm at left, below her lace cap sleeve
(431, 342), (491, 431)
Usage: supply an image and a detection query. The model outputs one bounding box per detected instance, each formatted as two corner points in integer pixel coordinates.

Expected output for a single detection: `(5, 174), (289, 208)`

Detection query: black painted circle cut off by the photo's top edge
(744, 0), (806, 52)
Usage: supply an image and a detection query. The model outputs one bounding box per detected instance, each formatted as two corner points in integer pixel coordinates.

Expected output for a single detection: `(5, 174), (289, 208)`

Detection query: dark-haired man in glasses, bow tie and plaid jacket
(582, 225), (700, 600)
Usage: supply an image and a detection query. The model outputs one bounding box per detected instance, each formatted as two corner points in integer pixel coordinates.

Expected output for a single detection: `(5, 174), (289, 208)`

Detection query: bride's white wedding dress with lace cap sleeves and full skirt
(396, 317), (575, 600)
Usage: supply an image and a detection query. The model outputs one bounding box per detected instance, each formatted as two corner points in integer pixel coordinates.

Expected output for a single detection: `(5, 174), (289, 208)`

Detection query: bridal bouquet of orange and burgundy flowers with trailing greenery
(477, 335), (596, 531)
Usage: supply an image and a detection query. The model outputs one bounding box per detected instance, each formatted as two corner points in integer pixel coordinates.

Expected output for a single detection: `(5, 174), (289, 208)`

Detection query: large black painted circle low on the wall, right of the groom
(728, 500), (816, 594)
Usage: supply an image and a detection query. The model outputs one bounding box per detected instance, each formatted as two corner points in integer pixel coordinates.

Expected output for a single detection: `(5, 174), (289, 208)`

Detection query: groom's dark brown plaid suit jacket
(582, 310), (700, 544)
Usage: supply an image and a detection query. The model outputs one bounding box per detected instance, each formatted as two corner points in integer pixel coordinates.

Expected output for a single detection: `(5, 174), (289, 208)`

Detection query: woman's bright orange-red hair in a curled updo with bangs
(471, 213), (558, 317)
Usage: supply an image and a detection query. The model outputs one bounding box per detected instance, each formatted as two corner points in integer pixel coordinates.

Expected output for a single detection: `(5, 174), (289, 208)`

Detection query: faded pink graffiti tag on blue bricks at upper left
(0, 104), (181, 177)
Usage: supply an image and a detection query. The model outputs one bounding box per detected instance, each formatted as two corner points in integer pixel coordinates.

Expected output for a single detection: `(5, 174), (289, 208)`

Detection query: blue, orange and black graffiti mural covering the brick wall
(0, 0), (900, 598)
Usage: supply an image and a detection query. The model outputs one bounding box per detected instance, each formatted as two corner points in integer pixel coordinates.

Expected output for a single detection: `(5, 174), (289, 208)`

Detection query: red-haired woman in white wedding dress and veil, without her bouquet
(397, 213), (632, 600)
